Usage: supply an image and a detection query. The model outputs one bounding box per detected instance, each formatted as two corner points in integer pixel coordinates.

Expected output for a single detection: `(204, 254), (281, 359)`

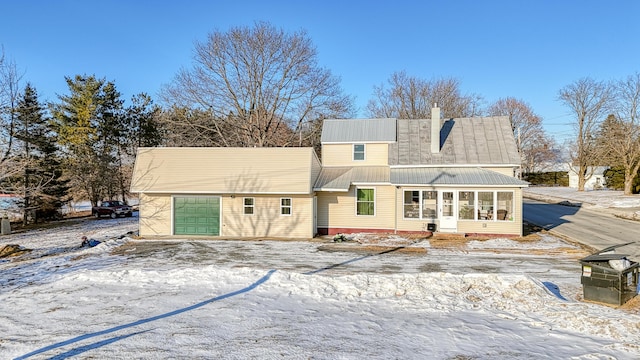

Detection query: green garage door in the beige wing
(173, 196), (220, 236)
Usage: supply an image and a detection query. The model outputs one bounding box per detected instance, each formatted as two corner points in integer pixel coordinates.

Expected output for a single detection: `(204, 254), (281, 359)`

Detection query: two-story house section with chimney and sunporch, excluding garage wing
(314, 107), (527, 235)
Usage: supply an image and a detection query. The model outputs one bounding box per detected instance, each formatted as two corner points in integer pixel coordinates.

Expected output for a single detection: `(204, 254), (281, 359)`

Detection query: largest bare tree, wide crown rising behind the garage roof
(162, 22), (352, 146)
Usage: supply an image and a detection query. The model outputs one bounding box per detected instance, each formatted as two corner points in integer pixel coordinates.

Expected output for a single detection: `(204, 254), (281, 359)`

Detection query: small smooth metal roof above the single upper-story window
(320, 118), (396, 143)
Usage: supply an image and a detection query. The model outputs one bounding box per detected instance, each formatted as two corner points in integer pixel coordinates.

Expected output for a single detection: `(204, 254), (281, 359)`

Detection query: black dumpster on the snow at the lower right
(580, 243), (639, 305)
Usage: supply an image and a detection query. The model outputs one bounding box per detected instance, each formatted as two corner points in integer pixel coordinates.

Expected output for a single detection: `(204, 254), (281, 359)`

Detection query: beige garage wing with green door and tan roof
(131, 147), (321, 238)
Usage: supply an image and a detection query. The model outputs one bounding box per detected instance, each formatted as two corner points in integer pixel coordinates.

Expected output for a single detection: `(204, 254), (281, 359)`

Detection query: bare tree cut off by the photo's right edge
(600, 73), (640, 195)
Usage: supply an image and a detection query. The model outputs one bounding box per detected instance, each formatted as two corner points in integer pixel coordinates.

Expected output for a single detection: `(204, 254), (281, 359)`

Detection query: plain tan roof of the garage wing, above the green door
(131, 147), (320, 194)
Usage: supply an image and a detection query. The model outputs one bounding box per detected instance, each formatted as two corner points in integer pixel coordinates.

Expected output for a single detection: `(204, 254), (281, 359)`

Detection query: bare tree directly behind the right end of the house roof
(487, 97), (556, 173)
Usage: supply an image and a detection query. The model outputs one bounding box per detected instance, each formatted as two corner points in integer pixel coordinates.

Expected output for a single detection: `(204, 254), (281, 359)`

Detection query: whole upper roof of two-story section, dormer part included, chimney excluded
(321, 116), (520, 166)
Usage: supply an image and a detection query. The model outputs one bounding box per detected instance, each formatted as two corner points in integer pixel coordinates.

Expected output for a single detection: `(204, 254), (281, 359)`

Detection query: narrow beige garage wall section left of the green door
(139, 194), (172, 236)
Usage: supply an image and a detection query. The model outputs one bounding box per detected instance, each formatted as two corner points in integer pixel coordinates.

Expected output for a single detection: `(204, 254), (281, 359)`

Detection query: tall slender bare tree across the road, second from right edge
(558, 78), (613, 191)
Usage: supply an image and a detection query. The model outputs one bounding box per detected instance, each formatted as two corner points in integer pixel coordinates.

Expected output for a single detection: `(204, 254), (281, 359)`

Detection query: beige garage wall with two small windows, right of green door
(220, 195), (315, 239)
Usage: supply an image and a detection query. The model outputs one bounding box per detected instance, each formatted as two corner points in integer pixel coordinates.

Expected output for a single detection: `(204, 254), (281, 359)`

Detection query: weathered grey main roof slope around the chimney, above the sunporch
(389, 116), (520, 166)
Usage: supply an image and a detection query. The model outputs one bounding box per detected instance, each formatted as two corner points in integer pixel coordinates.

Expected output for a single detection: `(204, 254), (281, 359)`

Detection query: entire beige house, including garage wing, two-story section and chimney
(131, 108), (528, 238)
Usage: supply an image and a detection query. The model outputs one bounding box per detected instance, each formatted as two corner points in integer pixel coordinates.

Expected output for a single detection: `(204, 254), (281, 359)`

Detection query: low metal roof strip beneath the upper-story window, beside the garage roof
(313, 166), (390, 191)
